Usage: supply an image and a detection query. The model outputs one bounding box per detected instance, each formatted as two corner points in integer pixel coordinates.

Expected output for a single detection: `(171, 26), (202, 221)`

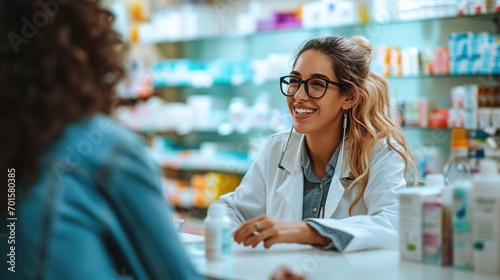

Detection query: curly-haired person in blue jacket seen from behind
(0, 0), (201, 280)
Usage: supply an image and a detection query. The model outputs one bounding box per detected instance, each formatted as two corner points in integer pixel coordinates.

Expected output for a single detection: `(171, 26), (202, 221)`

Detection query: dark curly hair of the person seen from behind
(0, 0), (125, 185)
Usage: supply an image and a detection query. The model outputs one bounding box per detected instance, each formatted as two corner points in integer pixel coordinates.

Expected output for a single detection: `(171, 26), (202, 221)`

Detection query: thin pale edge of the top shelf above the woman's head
(143, 12), (500, 44)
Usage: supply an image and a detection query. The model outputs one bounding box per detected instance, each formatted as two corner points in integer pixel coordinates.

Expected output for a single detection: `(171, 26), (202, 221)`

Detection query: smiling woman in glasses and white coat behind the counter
(212, 37), (417, 252)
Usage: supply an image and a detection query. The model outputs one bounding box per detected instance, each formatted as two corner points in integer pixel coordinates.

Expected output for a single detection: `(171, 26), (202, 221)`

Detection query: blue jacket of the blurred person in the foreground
(2, 114), (201, 280)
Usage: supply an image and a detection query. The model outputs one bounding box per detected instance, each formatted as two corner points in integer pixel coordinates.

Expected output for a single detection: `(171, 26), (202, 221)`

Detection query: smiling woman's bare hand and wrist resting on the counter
(233, 216), (329, 248)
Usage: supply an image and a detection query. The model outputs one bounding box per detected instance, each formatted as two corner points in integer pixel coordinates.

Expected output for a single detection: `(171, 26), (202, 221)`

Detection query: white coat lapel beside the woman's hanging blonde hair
(325, 147), (351, 218)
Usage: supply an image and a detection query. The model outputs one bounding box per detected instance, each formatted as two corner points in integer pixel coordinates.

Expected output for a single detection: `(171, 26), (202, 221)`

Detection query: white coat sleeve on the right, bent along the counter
(304, 145), (406, 252)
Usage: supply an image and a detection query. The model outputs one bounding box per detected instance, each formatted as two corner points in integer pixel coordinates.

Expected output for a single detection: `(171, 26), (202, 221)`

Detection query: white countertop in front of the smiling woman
(181, 234), (500, 280)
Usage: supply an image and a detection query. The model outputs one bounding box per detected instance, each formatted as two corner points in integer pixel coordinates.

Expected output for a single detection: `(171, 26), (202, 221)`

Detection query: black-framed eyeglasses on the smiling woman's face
(280, 76), (345, 99)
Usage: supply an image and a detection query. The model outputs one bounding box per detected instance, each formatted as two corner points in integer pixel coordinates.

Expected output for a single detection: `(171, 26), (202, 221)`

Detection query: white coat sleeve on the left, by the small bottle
(210, 138), (277, 231)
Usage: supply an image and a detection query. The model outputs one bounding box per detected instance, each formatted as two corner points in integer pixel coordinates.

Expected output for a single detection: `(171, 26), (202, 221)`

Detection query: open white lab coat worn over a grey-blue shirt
(217, 131), (406, 252)
